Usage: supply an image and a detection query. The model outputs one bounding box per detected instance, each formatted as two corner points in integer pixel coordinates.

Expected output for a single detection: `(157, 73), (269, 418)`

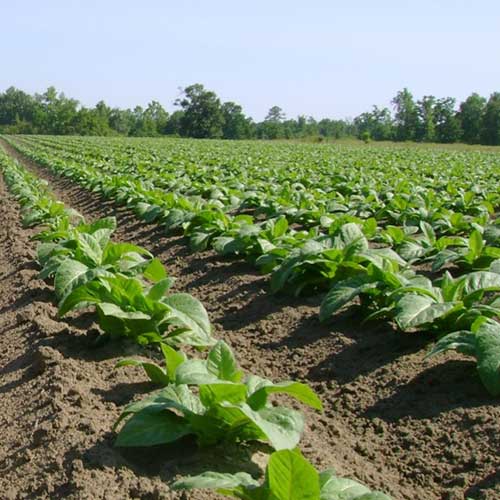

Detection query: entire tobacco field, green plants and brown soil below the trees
(0, 136), (500, 500)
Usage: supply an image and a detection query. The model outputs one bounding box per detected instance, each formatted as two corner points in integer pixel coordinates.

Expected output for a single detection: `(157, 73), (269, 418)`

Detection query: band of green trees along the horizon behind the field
(0, 83), (500, 145)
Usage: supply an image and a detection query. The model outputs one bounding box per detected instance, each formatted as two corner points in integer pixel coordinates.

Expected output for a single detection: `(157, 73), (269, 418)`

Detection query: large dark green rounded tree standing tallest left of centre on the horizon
(175, 83), (224, 139)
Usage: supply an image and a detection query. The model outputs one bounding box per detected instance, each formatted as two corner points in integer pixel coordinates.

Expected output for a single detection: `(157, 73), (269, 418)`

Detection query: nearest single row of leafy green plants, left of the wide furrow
(0, 146), (388, 500)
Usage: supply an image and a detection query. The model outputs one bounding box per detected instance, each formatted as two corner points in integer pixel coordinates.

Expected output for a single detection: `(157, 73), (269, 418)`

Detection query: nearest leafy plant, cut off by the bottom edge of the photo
(173, 450), (390, 500)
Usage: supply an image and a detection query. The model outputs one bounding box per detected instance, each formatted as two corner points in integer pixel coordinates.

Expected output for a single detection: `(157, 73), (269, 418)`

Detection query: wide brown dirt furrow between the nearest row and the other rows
(0, 140), (500, 500)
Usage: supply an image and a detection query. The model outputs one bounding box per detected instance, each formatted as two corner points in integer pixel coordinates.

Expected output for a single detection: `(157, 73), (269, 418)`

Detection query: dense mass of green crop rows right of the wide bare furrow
(4, 137), (500, 395)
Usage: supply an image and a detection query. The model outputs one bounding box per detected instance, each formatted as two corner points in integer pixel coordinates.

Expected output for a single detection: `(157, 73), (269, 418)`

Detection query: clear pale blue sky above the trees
(0, 0), (500, 120)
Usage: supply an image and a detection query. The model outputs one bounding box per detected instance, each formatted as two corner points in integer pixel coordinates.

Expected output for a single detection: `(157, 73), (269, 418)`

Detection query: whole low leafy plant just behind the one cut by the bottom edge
(115, 341), (322, 450)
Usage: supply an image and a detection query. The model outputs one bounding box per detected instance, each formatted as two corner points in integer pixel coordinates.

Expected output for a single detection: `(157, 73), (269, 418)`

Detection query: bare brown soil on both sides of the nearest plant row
(0, 141), (500, 500)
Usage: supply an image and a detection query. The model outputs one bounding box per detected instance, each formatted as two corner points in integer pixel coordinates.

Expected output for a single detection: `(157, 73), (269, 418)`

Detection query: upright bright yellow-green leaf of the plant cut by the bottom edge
(266, 450), (320, 500)
